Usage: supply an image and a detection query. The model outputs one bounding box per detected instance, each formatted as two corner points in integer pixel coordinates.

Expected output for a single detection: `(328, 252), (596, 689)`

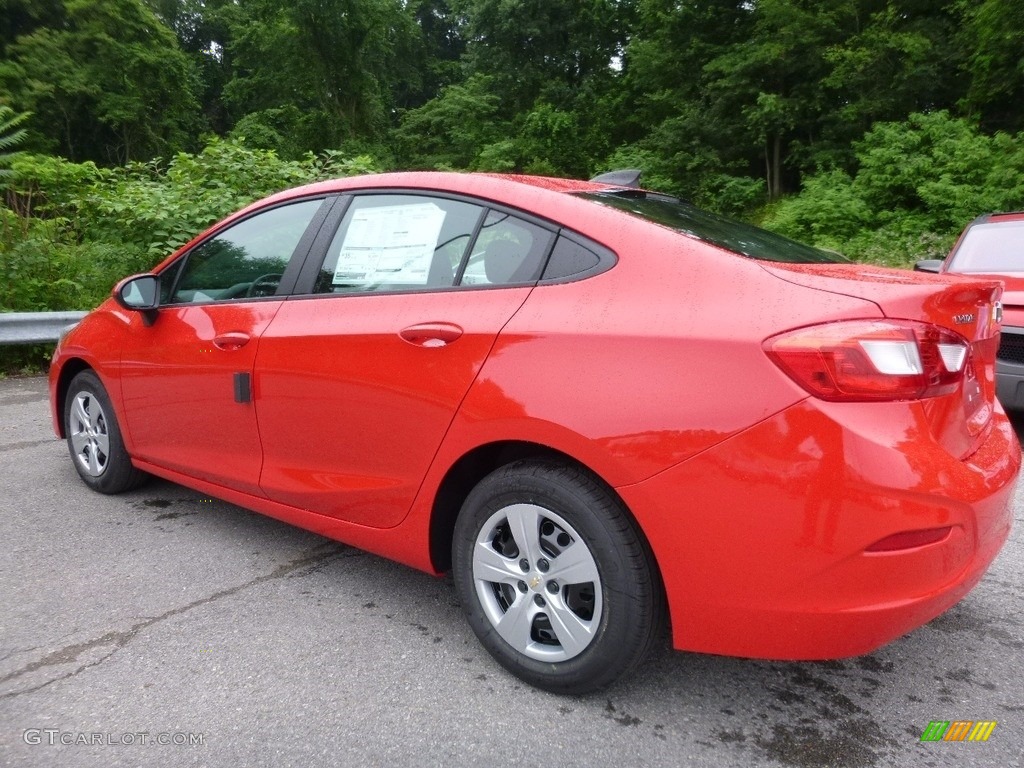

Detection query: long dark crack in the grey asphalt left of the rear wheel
(0, 547), (365, 700)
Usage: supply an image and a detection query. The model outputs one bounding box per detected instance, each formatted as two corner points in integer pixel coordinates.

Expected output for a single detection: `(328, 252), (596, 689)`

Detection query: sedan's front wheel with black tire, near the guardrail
(63, 371), (148, 494)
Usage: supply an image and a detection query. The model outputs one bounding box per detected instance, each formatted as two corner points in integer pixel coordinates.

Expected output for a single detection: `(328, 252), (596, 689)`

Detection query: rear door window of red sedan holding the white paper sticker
(314, 195), (484, 293)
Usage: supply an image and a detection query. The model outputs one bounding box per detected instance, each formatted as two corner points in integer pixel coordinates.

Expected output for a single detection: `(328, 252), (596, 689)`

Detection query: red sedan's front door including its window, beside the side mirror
(122, 200), (333, 494)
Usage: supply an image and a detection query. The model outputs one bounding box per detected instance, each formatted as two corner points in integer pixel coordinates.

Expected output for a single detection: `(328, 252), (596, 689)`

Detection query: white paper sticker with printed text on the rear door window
(332, 203), (445, 286)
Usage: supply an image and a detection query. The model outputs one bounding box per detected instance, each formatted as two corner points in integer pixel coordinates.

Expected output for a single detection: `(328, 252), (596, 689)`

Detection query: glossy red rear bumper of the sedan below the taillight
(617, 400), (1021, 659)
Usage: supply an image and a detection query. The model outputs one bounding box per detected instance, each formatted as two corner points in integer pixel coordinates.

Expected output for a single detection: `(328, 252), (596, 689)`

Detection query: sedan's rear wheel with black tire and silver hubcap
(452, 460), (664, 693)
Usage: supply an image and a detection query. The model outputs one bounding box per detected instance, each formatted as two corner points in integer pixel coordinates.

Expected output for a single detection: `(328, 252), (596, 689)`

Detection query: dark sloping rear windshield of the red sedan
(582, 191), (848, 264)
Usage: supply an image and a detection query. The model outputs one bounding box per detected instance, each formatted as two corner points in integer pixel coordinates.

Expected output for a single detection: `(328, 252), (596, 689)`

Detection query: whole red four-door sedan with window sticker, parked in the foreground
(50, 173), (1021, 692)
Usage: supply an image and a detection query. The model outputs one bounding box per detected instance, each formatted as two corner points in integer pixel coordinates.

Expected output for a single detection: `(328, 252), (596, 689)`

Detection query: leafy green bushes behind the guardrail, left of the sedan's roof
(0, 139), (375, 319)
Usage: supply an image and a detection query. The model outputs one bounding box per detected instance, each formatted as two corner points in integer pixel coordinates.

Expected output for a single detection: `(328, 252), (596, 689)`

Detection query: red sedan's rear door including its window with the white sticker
(255, 194), (553, 527)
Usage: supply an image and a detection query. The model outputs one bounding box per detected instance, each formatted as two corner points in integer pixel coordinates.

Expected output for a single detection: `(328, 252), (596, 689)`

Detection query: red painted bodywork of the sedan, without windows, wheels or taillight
(50, 173), (1021, 658)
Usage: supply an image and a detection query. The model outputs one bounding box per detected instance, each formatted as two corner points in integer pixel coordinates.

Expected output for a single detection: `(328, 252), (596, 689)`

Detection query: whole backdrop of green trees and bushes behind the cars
(0, 0), (1024, 348)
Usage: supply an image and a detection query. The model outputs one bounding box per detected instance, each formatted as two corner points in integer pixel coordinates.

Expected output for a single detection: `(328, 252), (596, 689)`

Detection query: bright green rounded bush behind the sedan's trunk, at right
(762, 112), (1024, 266)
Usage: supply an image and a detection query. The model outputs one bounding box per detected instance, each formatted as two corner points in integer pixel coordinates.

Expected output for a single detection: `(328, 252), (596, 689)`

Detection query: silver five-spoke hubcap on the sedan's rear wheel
(473, 504), (602, 662)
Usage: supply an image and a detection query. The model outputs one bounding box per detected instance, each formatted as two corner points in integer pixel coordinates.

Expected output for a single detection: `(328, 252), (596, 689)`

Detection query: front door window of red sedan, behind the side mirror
(167, 200), (323, 304)
